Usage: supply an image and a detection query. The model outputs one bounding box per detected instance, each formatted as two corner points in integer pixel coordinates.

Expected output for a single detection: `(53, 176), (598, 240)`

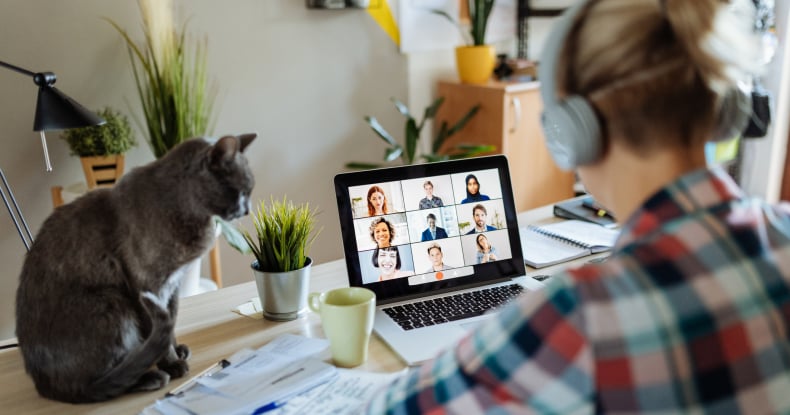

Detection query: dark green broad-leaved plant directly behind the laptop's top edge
(346, 97), (496, 169)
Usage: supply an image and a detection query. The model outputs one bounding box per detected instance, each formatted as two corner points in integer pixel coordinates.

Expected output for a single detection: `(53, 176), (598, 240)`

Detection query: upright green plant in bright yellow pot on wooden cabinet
(433, 0), (496, 84)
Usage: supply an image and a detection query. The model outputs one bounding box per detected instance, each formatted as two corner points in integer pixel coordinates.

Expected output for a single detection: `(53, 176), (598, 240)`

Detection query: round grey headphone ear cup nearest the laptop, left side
(541, 95), (603, 170)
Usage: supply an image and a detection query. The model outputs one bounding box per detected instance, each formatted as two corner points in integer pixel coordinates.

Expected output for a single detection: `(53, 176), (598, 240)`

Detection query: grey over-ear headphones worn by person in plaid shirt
(538, 0), (752, 170)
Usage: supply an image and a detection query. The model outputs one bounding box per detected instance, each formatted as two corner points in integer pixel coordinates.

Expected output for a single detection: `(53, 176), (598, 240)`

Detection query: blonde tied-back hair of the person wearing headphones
(555, 0), (759, 154)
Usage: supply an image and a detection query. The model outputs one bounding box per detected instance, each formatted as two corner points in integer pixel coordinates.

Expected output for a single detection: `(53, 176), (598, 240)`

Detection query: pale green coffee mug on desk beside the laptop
(307, 287), (376, 367)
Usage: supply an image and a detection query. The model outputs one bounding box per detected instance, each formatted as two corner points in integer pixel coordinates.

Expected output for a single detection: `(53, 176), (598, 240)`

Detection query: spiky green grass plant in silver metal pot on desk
(241, 197), (320, 321)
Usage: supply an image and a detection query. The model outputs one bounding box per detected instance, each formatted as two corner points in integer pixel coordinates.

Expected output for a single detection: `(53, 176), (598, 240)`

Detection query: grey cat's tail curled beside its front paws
(85, 292), (174, 401)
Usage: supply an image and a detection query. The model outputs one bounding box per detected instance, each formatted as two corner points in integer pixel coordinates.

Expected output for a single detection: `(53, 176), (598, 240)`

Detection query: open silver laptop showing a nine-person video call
(334, 155), (526, 366)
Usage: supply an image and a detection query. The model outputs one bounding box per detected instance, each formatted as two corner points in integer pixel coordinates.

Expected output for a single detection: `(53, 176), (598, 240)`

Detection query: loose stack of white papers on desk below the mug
(142, 334), (397, 415)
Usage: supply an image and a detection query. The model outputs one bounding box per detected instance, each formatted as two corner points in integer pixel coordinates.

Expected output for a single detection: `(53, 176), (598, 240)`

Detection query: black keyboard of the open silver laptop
(382, 284), (524, 330)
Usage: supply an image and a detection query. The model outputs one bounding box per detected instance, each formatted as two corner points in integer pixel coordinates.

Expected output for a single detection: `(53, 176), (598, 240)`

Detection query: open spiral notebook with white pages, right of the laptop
(519, 219), (620, 268)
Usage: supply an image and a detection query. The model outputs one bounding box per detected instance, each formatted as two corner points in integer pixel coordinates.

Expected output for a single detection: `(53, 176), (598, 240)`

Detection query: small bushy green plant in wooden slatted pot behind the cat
(60, 107), (137, 189)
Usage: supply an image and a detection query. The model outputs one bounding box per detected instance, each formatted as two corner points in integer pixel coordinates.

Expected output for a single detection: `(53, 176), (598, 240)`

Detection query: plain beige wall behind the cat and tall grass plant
(0, 0), (408, 339)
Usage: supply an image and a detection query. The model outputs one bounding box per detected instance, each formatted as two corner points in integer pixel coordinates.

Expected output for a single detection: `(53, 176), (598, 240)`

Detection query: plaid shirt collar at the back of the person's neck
(617, 167), (745, 247)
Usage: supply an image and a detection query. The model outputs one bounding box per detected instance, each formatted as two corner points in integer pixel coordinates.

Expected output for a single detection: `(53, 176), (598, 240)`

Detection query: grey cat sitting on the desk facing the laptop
(16, 134), (256, 403)
